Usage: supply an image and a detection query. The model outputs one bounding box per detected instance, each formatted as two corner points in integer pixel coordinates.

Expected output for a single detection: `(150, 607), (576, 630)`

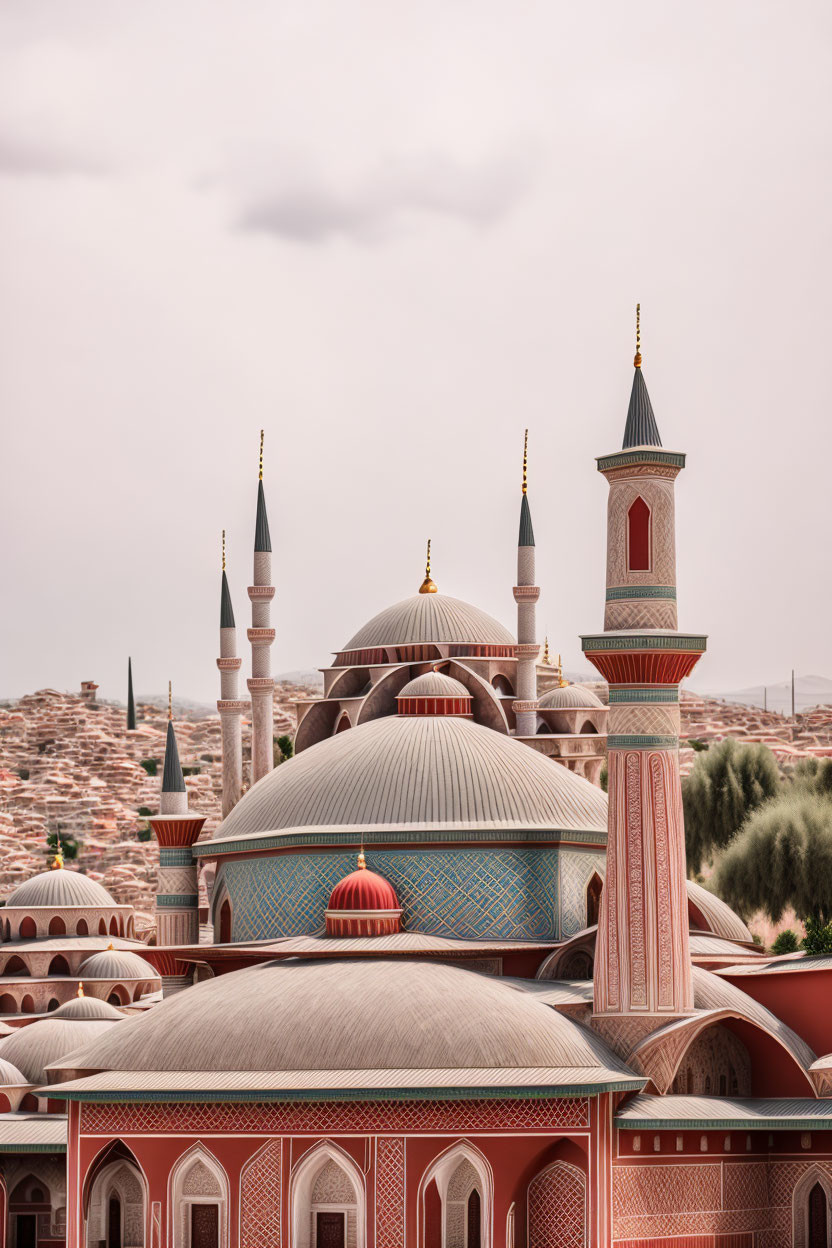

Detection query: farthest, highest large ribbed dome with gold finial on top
(343, 594), (516, 650)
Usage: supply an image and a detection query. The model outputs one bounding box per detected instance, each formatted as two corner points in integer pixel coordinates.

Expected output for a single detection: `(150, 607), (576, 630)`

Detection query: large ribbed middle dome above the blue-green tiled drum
(215, 715), (606, 841)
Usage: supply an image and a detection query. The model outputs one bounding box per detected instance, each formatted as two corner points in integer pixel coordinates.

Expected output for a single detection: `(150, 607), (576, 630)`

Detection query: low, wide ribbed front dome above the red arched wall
(48, 958), (623, 1076)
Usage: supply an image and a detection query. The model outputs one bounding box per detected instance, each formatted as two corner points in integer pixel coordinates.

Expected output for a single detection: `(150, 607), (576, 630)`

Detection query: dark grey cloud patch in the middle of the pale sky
(237, 154), (531, 245)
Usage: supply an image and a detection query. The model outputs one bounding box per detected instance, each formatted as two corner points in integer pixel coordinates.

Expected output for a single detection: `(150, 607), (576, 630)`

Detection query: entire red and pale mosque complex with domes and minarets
(0, 314), (832, 1248)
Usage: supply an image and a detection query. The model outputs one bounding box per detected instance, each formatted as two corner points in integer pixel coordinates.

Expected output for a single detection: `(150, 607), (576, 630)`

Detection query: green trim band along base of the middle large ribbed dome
(193, 825), (606, 857)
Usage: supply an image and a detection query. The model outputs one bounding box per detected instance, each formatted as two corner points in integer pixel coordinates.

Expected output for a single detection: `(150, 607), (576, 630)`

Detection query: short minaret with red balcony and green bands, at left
(148, 684), (205, 996)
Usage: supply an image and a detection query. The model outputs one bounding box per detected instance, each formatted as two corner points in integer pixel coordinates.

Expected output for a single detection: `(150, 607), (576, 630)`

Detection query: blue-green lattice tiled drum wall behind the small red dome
(215, 849), (604, 941)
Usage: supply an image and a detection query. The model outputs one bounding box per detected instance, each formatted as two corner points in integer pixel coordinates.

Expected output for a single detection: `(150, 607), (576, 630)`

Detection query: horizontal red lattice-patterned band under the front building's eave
(81, 1097), (589, 1136)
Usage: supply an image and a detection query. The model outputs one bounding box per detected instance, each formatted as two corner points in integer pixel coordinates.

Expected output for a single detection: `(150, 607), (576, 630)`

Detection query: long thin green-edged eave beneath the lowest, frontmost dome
(49, 1077), (647, 1104)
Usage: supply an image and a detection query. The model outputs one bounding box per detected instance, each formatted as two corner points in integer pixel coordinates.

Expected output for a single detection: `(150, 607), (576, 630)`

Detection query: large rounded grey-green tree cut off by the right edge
(715, 792), (832, 926)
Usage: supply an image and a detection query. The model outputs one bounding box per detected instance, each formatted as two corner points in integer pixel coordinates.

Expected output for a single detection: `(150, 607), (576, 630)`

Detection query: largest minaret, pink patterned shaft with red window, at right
(581, 308), (706, 1028)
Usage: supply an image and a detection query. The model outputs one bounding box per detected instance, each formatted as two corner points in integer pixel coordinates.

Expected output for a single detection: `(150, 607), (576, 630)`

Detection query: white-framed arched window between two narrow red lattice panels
(291, 1143), (365, 1248)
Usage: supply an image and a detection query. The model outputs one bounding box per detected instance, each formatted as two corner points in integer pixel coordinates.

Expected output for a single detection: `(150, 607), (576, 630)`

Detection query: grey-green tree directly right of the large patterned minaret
(682, 738), (781, 874)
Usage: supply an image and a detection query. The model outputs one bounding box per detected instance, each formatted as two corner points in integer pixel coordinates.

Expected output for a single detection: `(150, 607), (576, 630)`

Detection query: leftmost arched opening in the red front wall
(86, 1143), (147, 1248)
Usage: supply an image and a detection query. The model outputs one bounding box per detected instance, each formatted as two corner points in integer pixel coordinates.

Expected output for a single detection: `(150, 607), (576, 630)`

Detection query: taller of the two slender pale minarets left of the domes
(247, 429), (274, 784)
